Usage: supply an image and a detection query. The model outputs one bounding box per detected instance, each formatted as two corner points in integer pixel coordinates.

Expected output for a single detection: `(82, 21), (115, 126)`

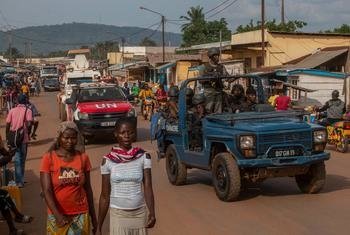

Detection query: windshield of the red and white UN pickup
(78, 87), (126, 102)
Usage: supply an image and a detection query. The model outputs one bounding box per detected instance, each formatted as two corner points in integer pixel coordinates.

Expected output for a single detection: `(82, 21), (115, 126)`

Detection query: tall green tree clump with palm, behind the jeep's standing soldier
(180, 6), (231, 47)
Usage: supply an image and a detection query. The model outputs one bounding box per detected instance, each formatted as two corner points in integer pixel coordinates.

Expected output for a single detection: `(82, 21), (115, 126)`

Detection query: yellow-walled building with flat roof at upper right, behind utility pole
(231, 30), (350, 71)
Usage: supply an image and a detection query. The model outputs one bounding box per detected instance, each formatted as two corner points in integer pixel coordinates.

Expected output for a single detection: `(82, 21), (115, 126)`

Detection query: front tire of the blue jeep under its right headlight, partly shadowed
(295, 162), (326, 194)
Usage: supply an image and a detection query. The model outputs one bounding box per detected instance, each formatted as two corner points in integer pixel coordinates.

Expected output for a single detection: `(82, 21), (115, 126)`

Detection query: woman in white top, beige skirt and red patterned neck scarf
(97, 118), (156, 235)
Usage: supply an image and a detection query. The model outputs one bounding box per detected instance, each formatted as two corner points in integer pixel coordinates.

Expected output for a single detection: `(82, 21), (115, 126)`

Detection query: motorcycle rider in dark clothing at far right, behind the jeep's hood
(316, 90), (345, 126)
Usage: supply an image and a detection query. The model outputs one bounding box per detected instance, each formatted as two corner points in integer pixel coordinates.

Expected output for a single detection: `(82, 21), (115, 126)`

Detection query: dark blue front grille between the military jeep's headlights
(258, 131), (312, 154)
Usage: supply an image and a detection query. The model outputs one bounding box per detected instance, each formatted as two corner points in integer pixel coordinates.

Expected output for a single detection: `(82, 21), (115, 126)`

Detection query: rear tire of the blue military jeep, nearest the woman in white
(165, 144), (187, 185)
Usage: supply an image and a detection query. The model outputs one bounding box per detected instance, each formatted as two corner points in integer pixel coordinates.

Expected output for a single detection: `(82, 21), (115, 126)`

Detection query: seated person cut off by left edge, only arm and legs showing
(0, 133), (34, 235)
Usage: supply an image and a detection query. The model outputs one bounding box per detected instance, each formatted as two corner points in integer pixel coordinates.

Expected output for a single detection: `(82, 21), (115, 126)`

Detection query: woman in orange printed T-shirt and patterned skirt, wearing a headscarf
(40, 122), (97, 235)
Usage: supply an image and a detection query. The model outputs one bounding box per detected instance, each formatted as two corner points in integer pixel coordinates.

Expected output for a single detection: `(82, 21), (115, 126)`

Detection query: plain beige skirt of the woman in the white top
(109, 207), (147, 235)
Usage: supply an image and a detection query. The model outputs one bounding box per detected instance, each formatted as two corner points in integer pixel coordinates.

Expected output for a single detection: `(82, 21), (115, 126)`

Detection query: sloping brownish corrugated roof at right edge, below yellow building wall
(291, 49), (348, 69)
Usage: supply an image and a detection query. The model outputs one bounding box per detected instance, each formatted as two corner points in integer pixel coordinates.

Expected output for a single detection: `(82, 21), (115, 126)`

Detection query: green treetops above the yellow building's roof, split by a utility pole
(236, 19), (307, 33)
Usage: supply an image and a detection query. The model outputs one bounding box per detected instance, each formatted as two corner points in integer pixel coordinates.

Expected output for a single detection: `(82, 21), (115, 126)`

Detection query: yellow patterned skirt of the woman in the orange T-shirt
(46, 212), (90, 235)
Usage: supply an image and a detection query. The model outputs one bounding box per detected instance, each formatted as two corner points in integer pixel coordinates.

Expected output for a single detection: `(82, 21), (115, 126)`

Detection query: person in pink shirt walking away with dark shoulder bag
(6, 94), (33, 187)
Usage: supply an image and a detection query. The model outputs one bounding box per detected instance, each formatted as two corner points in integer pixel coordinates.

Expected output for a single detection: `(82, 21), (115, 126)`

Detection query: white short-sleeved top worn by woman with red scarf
(101, 154), (151, 210)
